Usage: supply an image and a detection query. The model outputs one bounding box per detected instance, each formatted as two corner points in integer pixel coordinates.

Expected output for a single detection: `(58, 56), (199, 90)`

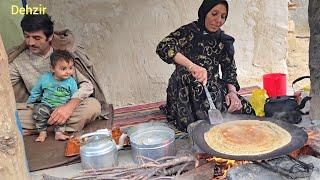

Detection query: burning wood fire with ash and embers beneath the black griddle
(190, 120), (320, 180)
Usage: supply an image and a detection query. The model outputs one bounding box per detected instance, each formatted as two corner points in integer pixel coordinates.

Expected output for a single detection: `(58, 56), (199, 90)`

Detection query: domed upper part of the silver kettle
(80, 136), (117, 156)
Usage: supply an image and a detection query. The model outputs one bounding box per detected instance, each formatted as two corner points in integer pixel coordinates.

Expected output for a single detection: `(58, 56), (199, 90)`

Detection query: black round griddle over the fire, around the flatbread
(192, 121), (308, 161)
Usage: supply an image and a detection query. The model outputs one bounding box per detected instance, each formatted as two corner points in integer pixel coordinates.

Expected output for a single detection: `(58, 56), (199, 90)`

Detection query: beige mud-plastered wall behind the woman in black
(26, 0), (288, 107)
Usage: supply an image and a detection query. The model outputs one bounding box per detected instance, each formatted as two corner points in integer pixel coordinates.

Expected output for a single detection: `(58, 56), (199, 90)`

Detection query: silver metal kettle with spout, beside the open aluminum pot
(80, 129), (127, 169)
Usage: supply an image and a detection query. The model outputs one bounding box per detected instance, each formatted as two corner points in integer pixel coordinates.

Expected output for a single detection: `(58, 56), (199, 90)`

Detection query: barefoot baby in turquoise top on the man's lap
(27, 50), (78, 142)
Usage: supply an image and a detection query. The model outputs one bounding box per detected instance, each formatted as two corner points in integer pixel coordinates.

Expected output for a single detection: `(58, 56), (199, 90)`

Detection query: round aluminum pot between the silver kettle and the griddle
(129, 124), (176, 164)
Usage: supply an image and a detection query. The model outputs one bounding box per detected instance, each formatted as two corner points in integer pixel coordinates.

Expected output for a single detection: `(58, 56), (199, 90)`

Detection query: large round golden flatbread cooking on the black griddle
(204, 120), (291, 156)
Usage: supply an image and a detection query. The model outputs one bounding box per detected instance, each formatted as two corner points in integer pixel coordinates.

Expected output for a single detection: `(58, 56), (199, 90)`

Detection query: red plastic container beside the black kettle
(263, 73), (287, 97)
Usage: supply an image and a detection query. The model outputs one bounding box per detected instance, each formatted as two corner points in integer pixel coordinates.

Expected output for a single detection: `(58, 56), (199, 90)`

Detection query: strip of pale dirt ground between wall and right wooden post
(287, 32), (310, 88)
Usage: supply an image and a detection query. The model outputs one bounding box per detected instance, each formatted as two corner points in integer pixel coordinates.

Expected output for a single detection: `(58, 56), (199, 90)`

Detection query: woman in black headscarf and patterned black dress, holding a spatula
(156, 0), (254, 131)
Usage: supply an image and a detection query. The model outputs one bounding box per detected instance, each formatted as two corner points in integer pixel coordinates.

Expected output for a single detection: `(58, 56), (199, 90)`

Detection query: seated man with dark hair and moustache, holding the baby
(9, 14), (101, 134)
